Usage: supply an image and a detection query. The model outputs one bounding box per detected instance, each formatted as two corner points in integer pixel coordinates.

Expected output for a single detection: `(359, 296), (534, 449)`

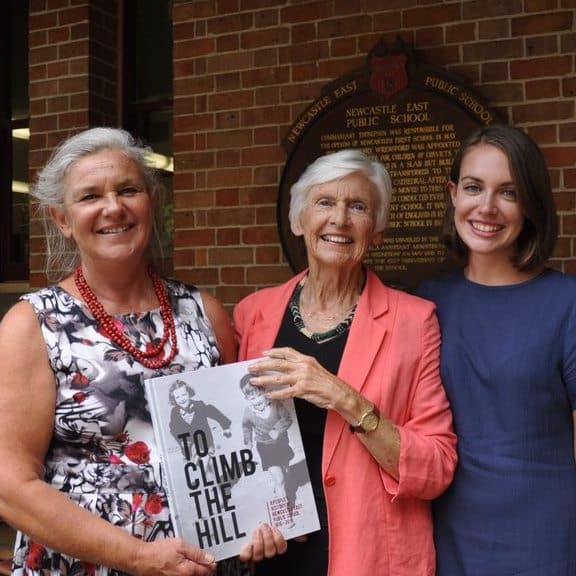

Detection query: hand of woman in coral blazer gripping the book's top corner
(248, 348), (350, 409)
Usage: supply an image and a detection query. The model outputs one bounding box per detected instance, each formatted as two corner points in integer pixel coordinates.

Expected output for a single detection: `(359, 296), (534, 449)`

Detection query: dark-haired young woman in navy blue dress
(419, 124), (576, 576)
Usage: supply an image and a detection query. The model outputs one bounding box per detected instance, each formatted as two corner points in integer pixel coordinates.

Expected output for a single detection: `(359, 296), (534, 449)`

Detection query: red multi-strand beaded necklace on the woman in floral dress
(74, 266), (178, 370)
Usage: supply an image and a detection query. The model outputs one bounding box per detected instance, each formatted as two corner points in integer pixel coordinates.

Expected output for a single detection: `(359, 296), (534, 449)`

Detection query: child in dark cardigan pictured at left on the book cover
(168, 380), (232, 454)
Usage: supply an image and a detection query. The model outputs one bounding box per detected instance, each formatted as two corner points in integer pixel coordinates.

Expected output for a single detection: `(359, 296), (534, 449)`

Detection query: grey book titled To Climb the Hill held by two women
(145, 360), (319, 560)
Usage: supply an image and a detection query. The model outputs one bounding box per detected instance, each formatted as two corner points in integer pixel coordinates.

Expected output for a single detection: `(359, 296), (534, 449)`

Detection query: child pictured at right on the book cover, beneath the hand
(240, 374), (295, 517)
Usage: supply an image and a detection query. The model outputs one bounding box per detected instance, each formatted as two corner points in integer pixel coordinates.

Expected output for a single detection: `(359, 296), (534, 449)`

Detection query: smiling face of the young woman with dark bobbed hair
(448, 144), (524, 261)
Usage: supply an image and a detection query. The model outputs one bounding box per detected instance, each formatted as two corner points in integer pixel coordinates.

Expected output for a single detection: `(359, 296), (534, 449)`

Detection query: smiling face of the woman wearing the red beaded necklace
(52, 149), (153, 272)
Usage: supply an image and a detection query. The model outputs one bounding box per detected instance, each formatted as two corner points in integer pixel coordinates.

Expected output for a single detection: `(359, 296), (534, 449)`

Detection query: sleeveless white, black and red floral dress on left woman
(12, 281), (247, 576)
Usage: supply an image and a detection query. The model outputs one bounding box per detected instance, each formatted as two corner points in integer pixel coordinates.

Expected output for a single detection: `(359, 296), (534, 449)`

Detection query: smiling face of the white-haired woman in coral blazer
(292, 173), (382, 268)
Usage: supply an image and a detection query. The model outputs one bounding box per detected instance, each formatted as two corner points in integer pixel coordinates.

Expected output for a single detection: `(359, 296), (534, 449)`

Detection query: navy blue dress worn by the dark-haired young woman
(420, 270), (576, 576)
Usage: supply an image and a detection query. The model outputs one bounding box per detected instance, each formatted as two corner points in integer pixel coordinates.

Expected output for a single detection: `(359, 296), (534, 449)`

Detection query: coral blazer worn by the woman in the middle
(234, 271), (457, 576)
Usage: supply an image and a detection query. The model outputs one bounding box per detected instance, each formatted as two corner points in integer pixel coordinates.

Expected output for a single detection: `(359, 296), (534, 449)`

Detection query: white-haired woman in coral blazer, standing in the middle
(234, 149), (457, 576)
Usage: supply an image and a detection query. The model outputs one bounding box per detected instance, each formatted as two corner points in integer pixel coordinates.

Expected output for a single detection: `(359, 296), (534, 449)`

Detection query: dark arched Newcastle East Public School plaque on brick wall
(278, 41), (499, 291)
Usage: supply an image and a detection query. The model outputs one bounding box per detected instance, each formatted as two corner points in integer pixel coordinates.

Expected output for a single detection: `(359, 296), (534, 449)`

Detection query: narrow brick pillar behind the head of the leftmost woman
(28, 0), (118, 286)
